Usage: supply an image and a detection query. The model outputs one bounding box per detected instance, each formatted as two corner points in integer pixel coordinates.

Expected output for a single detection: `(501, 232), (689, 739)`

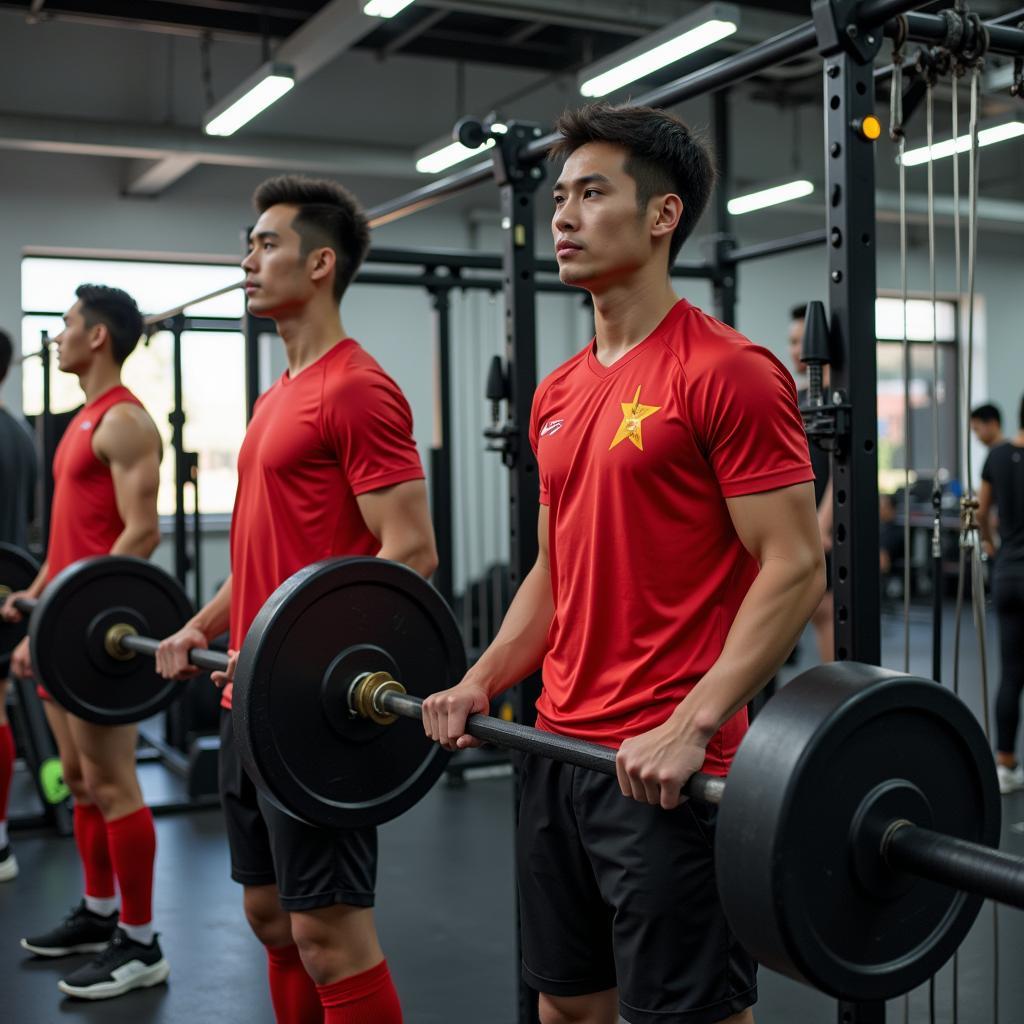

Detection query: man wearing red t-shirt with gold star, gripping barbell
(423, 104), (823, 1024)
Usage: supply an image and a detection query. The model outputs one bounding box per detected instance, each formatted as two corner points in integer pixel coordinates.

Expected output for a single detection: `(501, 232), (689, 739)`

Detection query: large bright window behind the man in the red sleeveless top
(22, 256), (246, 515)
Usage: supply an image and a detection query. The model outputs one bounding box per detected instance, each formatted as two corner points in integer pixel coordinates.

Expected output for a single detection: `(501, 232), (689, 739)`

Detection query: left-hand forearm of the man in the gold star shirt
(466, 564), (555, 697)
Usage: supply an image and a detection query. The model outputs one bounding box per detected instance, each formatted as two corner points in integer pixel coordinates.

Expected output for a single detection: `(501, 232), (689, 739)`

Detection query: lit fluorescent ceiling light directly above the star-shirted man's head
(578, 3), (739, 96)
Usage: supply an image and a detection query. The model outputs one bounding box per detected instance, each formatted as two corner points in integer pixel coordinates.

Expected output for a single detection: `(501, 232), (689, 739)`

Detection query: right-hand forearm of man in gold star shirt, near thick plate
(673, 556), (825, 742)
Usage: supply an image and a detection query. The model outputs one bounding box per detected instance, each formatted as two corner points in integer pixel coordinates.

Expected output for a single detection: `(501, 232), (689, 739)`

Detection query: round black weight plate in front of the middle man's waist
(232, 558), (466, 828)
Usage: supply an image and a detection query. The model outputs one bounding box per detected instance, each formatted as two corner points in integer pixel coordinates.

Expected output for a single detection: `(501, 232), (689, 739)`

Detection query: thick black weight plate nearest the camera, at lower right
(716, 662), (1000, 999)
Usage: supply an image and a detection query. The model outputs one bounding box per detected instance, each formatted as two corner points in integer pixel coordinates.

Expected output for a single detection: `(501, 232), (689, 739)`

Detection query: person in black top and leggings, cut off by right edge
(978, 398), (1024, 794)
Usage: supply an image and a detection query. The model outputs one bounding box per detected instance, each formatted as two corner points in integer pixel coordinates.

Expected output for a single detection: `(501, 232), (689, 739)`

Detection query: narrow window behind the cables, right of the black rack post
(874, 298), (961, 493)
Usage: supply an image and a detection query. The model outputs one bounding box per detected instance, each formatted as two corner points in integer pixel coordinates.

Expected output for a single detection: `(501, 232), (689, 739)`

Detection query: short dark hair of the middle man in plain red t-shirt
(253, 174), (370, 302)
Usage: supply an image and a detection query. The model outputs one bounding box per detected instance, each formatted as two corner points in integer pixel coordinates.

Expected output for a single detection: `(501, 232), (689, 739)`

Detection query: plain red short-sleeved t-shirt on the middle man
(221, 338), (424, 708)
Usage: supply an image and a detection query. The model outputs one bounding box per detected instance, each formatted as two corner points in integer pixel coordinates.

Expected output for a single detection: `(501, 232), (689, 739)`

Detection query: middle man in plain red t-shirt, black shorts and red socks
(157, 177), (437, 1024)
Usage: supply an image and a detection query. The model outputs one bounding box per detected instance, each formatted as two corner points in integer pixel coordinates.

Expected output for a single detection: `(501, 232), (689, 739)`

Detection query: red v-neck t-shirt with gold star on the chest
(530, 300), (813, 774)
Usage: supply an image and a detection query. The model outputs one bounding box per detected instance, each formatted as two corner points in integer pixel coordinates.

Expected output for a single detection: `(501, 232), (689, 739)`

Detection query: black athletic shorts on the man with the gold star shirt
(516, 755), (757, 1024)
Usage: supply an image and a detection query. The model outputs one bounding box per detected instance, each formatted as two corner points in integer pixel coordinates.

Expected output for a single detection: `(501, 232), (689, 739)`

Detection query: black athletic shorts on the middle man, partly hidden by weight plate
(218, 709), (377, 910)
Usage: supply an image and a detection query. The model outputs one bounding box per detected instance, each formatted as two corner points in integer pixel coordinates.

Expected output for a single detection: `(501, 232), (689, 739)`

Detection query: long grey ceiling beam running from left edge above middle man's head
(0, 113), (417, 180)
